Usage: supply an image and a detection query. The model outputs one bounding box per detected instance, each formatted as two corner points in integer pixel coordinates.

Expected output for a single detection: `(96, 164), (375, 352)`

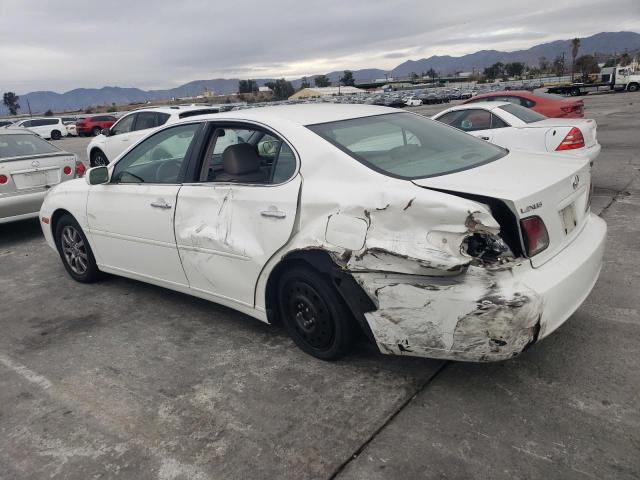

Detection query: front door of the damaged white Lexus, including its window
(87, 123), (201, 285)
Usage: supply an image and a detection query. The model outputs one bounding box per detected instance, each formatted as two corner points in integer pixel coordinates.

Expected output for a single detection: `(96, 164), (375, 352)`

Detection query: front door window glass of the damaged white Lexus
(111, 123), (201, 184)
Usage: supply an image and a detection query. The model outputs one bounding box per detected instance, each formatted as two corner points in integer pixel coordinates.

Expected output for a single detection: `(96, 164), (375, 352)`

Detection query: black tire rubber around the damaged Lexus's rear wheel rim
(278, 266), (354, 360)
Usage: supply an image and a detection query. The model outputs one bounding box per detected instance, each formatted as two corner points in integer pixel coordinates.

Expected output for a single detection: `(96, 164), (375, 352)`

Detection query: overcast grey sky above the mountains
(0, 0), (640, 94)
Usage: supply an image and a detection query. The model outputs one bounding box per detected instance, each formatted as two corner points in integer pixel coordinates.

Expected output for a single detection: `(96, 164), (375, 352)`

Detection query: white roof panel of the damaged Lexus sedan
(176, 103), (406, 126)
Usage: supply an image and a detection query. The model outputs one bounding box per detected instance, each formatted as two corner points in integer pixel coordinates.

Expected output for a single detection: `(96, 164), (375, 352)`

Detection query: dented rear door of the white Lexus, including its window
(175, 124), (301, 306)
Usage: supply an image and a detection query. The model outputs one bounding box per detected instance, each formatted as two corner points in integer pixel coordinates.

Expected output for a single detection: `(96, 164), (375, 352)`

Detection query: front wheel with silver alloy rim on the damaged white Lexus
(55, 215), (101, 283)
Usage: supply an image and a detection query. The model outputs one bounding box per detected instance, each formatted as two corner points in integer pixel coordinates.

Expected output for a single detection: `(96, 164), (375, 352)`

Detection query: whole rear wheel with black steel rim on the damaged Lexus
(278, 266), (354, 360)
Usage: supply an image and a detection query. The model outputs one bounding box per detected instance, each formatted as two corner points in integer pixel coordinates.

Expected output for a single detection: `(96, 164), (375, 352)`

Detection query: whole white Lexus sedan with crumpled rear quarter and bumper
(40, 104), (606, 361)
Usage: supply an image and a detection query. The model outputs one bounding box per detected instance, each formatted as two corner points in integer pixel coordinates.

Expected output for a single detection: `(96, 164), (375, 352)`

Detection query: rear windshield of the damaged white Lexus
(308, 113), (507, 179)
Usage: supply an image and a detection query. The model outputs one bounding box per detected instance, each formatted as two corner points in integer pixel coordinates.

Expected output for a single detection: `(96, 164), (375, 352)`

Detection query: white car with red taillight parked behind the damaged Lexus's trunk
(432, 102), (600, 162)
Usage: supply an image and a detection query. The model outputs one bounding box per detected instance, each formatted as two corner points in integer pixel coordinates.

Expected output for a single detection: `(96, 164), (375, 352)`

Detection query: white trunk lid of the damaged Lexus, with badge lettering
(413, 152), (591, 267)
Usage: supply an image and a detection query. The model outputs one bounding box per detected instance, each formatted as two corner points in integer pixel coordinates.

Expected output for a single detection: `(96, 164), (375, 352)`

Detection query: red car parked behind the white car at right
(462, 90), (584, 118)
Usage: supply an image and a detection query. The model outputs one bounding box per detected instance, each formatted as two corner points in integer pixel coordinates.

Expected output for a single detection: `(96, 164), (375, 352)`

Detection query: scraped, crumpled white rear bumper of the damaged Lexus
(353, 215), (607, 361)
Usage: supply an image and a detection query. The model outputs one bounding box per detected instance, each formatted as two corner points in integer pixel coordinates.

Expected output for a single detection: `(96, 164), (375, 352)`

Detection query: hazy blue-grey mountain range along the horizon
(0, 32), (640, 114)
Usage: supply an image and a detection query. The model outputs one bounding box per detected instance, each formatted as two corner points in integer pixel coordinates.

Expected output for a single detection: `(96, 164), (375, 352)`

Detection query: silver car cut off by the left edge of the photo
(0, 127), (84, 223)
